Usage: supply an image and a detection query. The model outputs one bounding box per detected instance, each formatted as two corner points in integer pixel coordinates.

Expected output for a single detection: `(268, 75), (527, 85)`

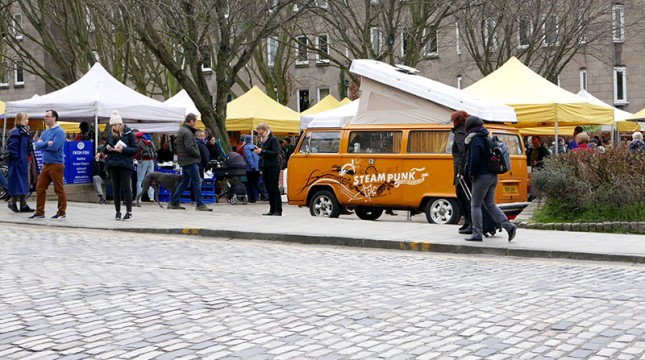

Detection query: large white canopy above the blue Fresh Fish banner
(6, 63), (184, 136)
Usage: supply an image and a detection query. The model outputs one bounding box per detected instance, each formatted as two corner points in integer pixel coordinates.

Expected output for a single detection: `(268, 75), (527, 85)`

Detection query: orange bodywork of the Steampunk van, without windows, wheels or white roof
(287, 124), (528, 210)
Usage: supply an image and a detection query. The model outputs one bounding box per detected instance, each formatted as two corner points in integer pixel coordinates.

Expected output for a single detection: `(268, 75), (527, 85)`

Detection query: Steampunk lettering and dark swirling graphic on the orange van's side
(299, 159), (429, 202)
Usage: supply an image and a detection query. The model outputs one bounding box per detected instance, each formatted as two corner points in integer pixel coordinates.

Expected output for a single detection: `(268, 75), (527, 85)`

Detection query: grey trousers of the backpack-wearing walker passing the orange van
(470, 174), (513, 239)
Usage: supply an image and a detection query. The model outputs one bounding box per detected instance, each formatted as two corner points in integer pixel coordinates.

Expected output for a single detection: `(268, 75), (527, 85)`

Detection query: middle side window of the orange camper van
(347, 131), (403, 154)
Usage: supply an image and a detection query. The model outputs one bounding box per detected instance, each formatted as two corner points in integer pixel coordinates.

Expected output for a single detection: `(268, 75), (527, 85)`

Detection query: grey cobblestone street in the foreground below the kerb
(0, 224), (645, 359)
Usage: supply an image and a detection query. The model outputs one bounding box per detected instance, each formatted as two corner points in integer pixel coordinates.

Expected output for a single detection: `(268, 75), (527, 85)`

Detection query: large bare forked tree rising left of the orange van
(119, 0), (314, 146)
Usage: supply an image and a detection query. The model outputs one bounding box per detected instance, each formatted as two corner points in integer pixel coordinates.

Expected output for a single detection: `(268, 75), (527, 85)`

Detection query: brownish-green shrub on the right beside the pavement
(531, 148), (645, 221)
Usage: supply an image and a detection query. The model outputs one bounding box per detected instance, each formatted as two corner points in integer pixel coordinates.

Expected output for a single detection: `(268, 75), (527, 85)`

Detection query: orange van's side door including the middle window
(339, 130), (403, 207)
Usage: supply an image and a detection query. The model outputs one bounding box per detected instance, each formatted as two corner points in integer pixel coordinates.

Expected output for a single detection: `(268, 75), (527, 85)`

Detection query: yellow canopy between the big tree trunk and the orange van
(226, 86), (300, 134)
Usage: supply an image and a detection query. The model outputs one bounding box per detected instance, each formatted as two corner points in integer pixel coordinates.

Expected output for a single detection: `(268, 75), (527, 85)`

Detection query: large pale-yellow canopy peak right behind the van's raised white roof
(464, 57), (614, 128)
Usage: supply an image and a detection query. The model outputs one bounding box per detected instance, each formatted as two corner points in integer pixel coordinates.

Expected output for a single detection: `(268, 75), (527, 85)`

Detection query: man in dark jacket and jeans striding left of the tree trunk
(168, 113), (213, 211)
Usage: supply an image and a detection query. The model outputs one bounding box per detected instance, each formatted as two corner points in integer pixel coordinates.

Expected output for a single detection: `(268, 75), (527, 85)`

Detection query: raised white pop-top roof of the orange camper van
(349, 60), (517, 124)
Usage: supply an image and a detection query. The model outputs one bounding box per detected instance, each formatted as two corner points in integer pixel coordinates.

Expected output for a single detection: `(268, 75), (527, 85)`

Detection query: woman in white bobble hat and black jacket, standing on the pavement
(103, 110), (139, 221)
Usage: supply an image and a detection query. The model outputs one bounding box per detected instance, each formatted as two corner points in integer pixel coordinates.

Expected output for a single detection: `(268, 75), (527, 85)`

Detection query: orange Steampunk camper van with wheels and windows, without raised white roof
(287, 124), (527, 224)
